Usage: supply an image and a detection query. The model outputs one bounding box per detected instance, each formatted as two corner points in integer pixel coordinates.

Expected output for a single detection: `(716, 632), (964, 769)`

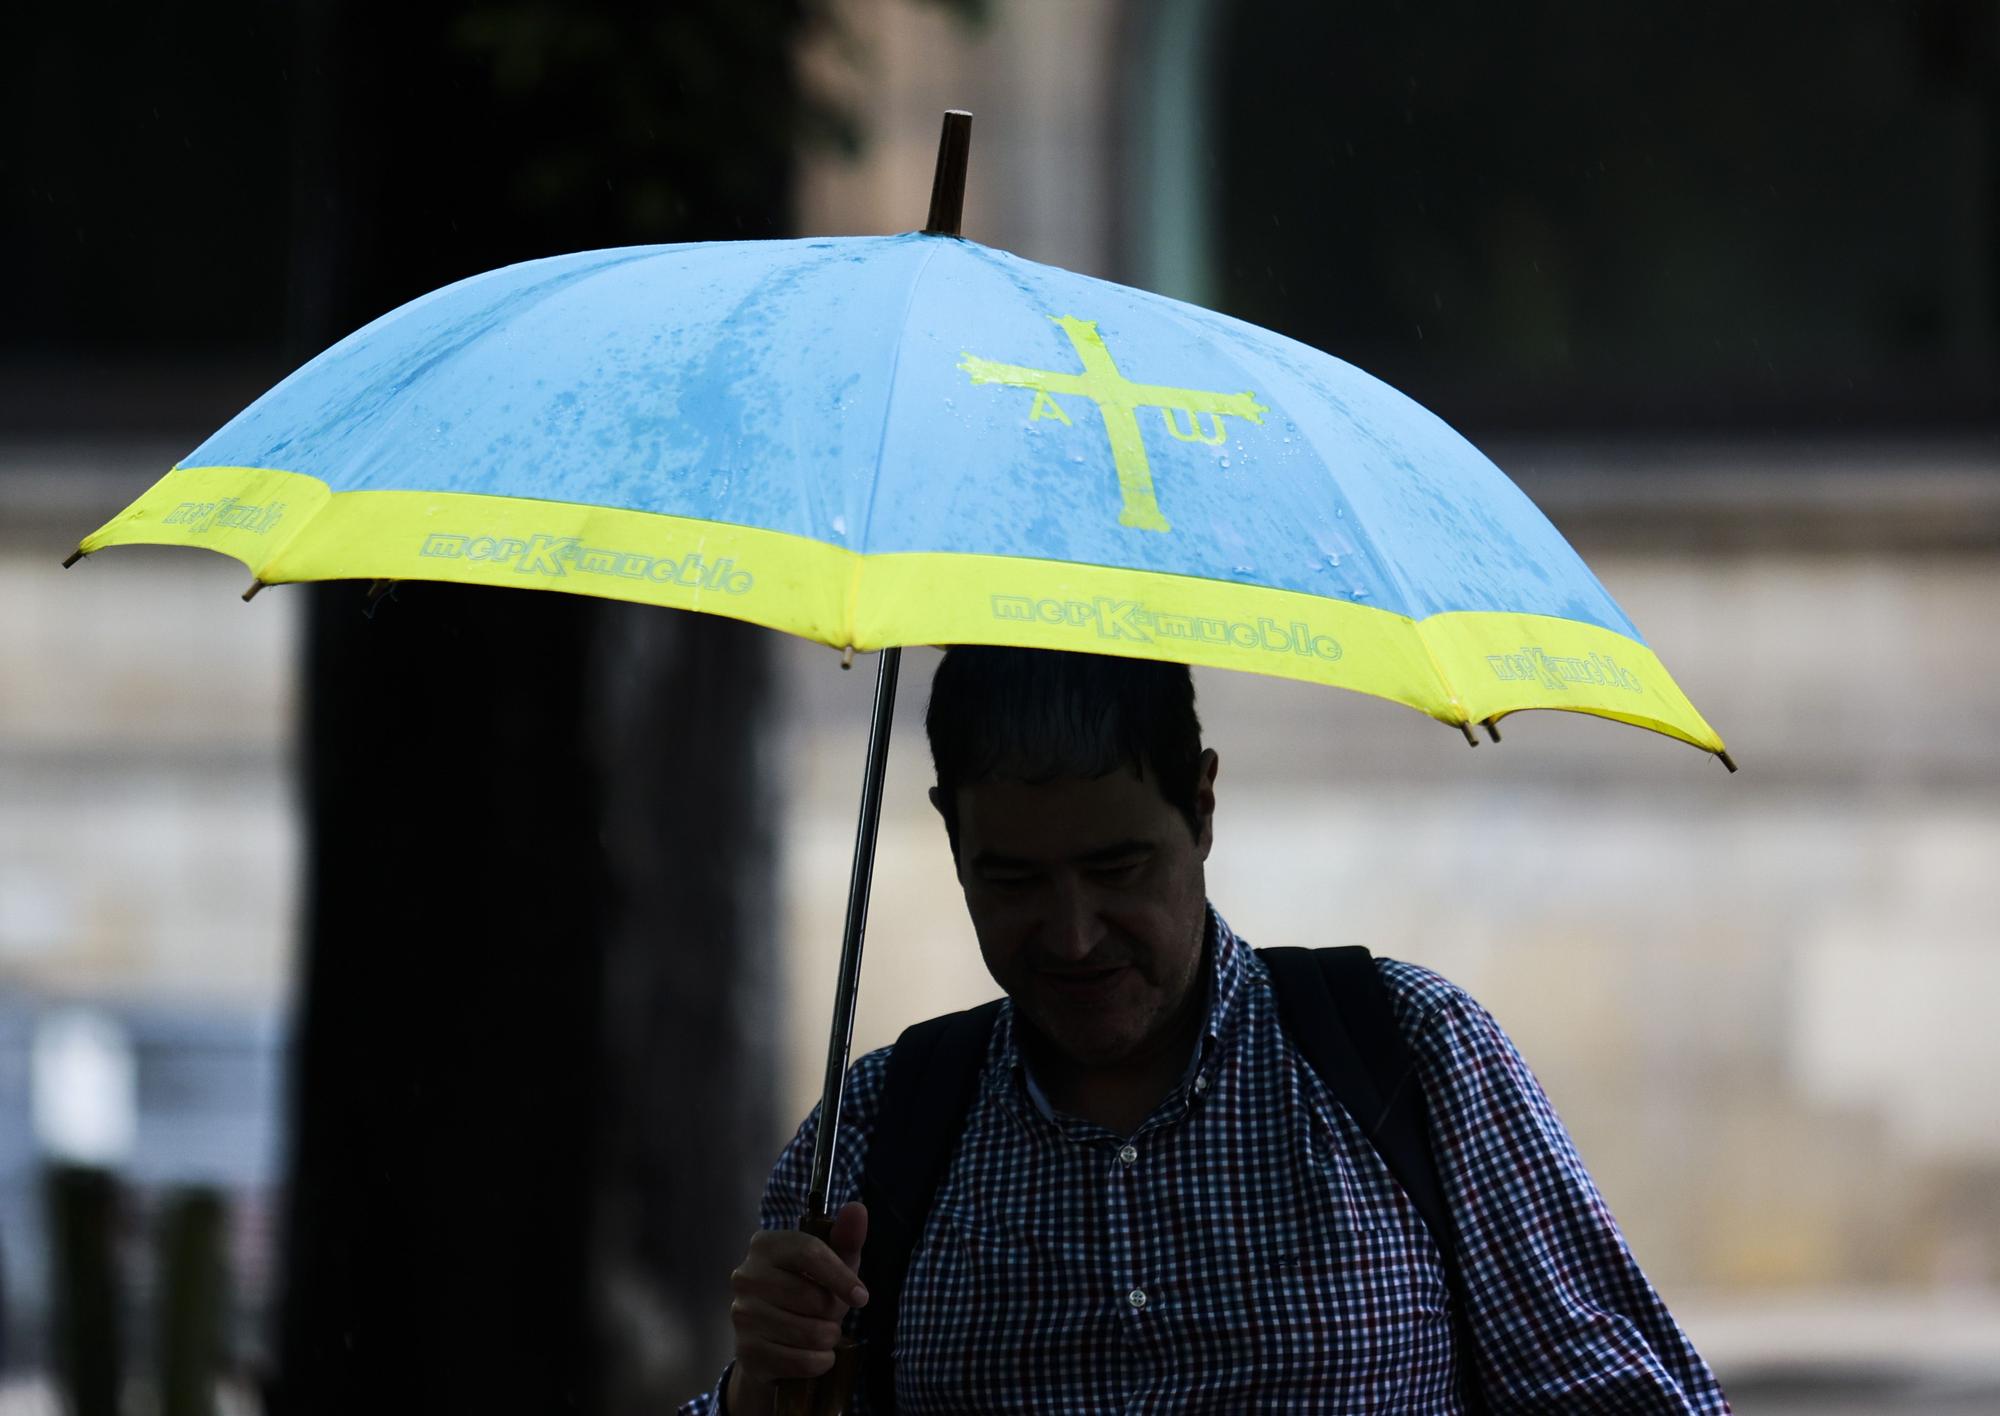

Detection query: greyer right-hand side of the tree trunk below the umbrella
(592, 606), (776, 1416)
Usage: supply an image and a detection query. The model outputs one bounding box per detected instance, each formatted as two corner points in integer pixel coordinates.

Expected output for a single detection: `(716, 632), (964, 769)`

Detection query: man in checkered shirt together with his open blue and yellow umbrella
(66, 112), (1734, 1416)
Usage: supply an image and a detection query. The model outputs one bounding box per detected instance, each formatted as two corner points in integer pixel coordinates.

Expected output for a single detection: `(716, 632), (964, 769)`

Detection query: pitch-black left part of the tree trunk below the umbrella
(282, 586), (610, 1412)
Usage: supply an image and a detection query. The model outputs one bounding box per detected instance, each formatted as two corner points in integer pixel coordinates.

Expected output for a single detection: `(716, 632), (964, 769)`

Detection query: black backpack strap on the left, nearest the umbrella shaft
(860, 998), (1000, 1416)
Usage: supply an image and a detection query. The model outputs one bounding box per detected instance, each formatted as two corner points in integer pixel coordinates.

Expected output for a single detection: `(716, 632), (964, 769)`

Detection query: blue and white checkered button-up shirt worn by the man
(680, 916), (1728, 1416)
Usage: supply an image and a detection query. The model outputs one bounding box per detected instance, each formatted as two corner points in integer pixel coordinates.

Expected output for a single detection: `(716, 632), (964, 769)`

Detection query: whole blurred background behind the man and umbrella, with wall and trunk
(0, 0), (2000, 1416)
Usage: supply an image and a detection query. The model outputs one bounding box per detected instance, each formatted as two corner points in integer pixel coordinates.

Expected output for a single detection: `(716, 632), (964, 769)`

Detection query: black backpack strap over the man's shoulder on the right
(1258, 944), (1486, 1412)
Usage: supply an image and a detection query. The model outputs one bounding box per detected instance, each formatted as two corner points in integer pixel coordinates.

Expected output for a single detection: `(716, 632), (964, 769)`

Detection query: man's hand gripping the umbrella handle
(728, 1202), (868, 1416)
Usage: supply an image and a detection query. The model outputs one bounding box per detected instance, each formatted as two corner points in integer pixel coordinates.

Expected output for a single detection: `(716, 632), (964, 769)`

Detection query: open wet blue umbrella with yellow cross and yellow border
(58, 112), (1734, 1416)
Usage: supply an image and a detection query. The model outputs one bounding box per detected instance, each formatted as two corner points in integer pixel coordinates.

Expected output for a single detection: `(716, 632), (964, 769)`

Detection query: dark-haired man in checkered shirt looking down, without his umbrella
(684, 648), (1728, 1416)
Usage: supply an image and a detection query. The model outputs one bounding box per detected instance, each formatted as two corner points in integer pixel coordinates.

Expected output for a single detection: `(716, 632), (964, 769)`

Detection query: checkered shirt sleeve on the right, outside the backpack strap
(1384, 962), (1730, 1416)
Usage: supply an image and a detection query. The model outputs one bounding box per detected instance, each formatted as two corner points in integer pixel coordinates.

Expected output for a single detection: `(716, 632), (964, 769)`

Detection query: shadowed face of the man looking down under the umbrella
(936, 752), (1216, 1066)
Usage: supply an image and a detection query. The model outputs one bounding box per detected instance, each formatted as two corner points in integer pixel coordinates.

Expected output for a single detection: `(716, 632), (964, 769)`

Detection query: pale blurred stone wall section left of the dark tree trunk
(0, 442), (298, 1008)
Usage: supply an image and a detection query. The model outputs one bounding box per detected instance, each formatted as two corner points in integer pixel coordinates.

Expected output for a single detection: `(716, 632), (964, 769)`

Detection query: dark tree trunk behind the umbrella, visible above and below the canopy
(270, 0), (808, 1414)
